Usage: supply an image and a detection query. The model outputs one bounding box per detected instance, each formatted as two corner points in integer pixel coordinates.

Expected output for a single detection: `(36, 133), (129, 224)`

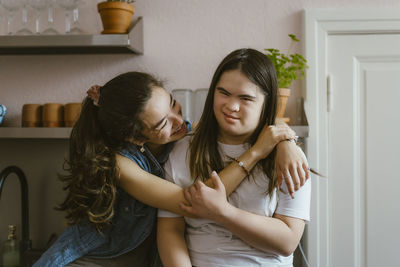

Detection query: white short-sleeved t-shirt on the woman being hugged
(158, 136), (311, 267)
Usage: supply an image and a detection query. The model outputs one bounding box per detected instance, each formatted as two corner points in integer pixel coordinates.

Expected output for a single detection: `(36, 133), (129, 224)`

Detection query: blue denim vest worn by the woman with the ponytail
(33, 141), (177, 267)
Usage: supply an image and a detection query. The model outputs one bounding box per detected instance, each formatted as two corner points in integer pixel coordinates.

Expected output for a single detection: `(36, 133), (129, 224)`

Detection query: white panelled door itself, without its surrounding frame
(327, 34), (400, 267)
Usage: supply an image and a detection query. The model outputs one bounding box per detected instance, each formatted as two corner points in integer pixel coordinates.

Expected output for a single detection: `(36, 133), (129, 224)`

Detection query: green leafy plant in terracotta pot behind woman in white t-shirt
(265, 34), (308, 122)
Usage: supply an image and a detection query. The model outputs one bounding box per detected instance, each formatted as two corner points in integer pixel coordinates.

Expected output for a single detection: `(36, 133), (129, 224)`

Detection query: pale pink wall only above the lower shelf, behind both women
(0, 0), (400, 126)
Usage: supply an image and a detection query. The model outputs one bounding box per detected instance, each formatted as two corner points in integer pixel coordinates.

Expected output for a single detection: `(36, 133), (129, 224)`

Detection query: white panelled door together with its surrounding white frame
(305, 9), (400, 267)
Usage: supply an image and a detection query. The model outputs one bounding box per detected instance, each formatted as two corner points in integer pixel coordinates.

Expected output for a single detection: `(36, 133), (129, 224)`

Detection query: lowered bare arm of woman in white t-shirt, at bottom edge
(157, 218), (192, 267)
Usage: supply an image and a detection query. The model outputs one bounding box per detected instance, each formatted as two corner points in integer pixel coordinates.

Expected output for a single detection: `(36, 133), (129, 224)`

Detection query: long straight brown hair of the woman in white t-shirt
(189, 49), (278, 193)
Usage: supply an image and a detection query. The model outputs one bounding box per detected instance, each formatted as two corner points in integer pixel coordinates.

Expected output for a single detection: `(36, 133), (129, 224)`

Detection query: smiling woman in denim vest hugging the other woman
(34, 72), (308, 266)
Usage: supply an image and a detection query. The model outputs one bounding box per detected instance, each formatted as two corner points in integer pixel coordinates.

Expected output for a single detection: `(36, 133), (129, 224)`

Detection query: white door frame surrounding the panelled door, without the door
(303, 8), (400, 267)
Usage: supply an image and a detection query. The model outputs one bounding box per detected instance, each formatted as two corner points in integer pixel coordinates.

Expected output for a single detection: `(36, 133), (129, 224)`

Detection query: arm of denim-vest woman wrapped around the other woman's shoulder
(116, 122), (306, 217)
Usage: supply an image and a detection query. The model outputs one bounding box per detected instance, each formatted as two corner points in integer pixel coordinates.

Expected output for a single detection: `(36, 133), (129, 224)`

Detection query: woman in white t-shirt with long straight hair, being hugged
(158, 49), (311, 267)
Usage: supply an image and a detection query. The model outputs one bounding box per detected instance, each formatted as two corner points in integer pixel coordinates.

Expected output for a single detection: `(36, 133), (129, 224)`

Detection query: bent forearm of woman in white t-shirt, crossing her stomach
(215, 205), (304, 256)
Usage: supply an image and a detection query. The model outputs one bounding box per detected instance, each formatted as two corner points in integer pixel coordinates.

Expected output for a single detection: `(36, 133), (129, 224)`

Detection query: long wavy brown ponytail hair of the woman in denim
(56, 72), (162, 231)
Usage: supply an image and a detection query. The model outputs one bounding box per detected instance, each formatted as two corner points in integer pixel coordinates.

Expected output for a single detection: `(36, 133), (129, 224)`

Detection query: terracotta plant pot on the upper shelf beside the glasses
(97, 2), (135, 34)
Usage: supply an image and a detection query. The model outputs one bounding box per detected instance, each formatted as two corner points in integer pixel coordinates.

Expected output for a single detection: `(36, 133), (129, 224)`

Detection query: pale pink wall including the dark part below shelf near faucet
(0, 0), (400, 255)
